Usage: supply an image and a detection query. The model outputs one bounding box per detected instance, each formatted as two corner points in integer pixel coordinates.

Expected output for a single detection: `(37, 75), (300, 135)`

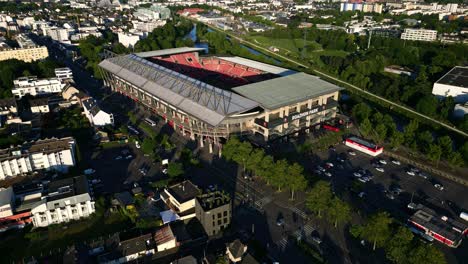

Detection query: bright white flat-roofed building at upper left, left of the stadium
(11, 76), (65, 98)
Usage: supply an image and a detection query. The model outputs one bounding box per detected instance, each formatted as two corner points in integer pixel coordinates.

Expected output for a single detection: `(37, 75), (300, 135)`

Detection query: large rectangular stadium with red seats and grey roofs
(99, 47), (342, 150)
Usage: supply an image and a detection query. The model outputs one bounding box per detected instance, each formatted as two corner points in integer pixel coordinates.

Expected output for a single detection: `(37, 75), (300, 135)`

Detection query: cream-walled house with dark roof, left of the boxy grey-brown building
(161, 180), (200, 220)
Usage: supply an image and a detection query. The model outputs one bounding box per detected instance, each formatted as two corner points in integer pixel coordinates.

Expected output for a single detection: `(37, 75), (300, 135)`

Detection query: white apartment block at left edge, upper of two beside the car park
(0, 137), (75, 180)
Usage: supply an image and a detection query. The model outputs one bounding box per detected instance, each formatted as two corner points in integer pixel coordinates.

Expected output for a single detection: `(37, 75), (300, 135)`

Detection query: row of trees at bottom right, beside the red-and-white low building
(350, 212), (447, 264)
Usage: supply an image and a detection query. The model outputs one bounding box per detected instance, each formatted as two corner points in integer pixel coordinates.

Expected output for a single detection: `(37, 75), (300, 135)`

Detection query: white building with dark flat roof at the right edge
(432, 66), (468, 103)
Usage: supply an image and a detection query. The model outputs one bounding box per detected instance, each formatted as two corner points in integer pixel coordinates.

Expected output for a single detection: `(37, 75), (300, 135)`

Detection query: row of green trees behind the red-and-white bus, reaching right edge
(352, 103), (468, 166)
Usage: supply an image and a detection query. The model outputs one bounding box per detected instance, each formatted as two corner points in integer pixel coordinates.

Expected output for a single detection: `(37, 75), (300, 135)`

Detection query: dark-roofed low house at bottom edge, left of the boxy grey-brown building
(98, 234), (155, 264)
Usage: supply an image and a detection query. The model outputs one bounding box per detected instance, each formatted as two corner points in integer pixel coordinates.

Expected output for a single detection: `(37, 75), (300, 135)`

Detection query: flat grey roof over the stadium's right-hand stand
(233, 72), (343, 110)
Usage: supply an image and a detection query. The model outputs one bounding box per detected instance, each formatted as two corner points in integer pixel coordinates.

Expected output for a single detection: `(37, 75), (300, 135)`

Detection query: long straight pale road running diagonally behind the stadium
(197, 21), (468, 137)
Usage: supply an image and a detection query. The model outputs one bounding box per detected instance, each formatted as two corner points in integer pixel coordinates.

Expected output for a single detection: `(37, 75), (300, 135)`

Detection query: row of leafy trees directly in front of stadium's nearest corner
(223, 137), (307, 199)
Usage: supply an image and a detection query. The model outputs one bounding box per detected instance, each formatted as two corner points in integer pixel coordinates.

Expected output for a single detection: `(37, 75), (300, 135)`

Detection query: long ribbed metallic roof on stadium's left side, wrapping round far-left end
(99, 53), (258, 126)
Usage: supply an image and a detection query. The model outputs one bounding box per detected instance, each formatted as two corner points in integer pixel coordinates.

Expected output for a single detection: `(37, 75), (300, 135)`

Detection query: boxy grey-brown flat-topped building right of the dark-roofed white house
(195, 191), (232, 236)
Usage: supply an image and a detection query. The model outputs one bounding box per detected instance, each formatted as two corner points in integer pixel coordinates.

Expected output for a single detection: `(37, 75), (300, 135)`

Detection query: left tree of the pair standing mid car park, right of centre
(306, 181), (333, 217)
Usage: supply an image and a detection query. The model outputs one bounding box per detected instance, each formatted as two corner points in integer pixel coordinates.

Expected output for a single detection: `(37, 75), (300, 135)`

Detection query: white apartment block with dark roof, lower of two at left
(31, 176), (96, 227)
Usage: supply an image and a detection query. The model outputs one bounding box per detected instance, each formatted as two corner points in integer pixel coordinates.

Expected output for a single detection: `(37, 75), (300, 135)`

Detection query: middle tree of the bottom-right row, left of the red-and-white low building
(385, 226), (414, 264)
